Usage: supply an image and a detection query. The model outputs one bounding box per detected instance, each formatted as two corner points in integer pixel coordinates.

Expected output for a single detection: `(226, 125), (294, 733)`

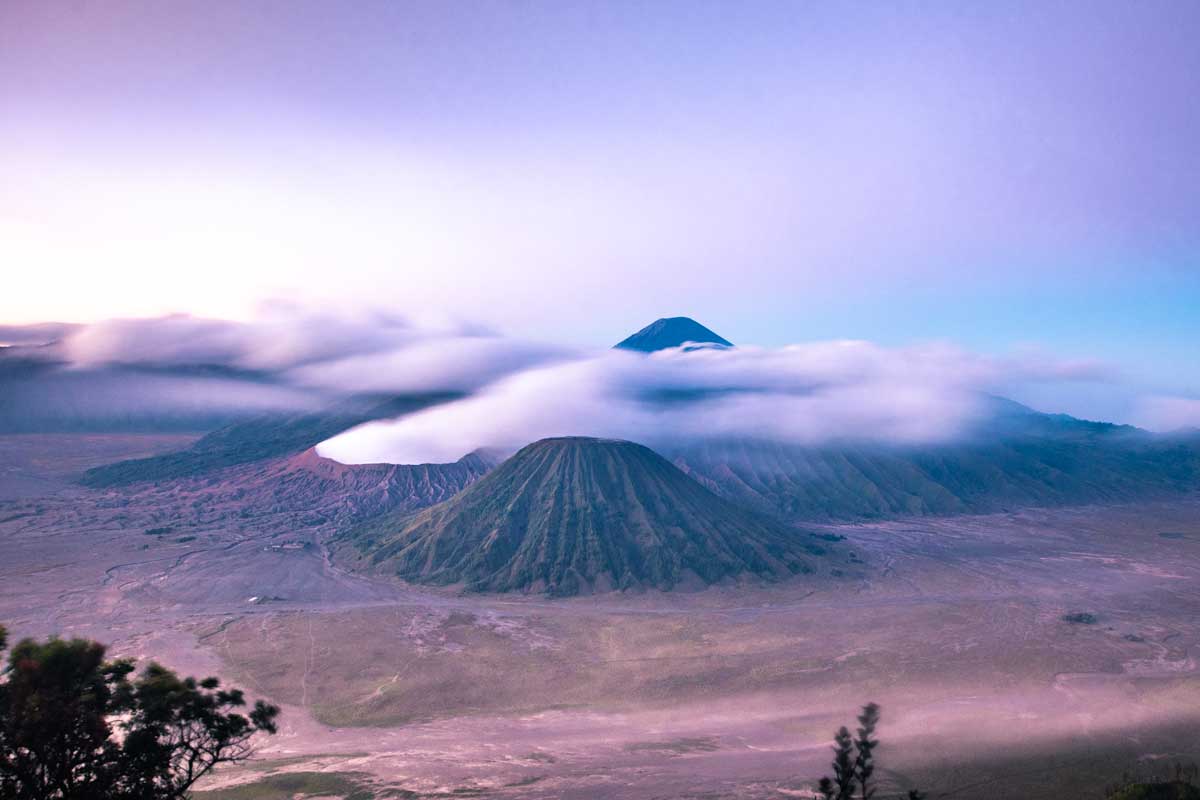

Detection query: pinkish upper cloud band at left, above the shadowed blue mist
(0, 306), (564, 393)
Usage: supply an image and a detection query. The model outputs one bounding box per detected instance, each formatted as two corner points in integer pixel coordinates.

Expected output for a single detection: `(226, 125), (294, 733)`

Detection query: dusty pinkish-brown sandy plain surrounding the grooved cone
(0, 435), (1200, 800)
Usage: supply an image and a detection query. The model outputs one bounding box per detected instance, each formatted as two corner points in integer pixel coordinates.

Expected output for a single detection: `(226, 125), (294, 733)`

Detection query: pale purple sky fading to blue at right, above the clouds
(0, 0), (1200, 416)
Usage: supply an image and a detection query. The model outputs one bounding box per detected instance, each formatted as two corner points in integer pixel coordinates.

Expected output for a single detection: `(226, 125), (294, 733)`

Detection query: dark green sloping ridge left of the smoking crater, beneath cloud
(83, 395), (455, 488)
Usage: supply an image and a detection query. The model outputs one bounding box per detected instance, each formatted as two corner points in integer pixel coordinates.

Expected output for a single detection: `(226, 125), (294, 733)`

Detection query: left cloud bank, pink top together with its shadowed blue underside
(0, 306), (565, 429)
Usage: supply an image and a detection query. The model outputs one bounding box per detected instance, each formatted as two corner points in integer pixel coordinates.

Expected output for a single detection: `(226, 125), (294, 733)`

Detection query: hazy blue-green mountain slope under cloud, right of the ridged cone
(667, 402), (1200, 522)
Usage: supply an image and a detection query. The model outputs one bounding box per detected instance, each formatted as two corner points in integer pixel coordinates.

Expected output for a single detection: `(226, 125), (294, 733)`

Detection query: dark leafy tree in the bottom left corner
(0, 627), (278, 800)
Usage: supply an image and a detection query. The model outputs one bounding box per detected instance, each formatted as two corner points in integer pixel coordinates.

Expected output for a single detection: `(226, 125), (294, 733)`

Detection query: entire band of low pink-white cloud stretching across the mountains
(0, 306), (1132, 455)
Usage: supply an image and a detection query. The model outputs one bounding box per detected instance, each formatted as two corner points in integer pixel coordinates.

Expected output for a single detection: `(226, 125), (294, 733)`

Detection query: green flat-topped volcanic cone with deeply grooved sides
(332, 438), (823, 595)
